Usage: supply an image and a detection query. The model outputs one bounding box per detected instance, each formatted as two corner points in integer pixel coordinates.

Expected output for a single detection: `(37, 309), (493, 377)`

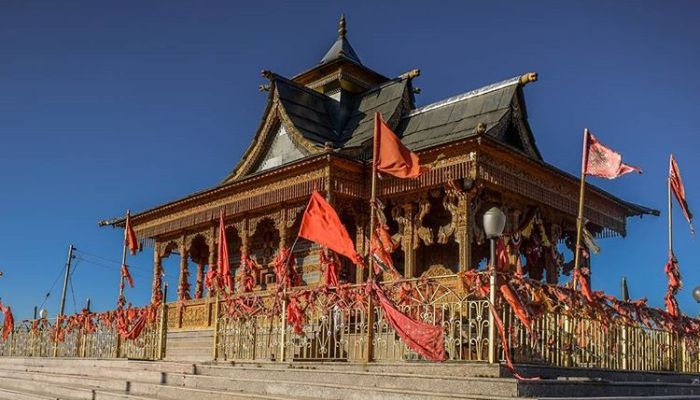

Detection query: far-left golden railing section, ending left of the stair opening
(0, 308), (164, 360)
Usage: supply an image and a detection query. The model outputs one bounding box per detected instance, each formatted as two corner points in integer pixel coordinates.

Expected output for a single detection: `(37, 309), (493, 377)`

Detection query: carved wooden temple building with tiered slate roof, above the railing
(101, 14), (658, 300)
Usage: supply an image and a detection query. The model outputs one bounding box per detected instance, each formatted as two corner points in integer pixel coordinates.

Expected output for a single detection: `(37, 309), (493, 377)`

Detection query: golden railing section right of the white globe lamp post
(501, 306), (700, 373)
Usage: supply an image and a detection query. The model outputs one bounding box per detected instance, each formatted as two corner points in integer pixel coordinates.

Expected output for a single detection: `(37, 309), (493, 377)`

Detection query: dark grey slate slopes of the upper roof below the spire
(266, 75), (541, 158)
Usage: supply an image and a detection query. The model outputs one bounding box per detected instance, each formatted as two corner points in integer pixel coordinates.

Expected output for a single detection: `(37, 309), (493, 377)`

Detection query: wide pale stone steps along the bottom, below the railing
(0, 358), (700, 400)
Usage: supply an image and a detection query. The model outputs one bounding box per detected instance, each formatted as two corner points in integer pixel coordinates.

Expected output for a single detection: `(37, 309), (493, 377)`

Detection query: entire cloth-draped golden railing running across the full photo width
(0, 271), (700, 374)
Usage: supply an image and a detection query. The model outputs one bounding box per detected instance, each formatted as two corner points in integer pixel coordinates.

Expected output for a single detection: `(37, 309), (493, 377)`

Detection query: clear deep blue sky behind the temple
(0, 0), (700, 318)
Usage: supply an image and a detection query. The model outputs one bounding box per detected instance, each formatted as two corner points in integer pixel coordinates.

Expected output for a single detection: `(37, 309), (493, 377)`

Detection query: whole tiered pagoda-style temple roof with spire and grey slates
(101, 18), (657, 234)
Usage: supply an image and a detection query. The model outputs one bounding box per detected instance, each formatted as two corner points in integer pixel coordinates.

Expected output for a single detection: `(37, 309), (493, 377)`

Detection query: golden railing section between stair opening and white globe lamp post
(215, 276), (489, 361)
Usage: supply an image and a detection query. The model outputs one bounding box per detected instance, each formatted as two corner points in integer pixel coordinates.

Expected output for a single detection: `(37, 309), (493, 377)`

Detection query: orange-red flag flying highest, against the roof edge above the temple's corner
(374, 113), (427, 178)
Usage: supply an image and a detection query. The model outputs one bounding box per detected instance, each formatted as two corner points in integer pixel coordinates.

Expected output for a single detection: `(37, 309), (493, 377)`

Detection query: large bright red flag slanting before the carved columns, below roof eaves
(299, 192), (362, 265)
